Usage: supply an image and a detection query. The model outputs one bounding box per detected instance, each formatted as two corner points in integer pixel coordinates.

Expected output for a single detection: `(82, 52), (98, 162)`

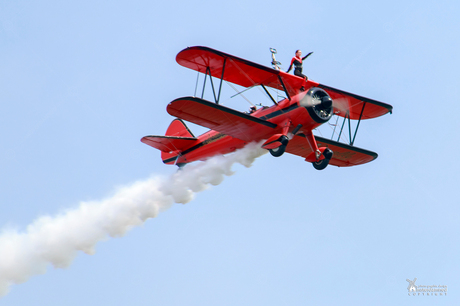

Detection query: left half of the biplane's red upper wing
(176, 46), (310, 96)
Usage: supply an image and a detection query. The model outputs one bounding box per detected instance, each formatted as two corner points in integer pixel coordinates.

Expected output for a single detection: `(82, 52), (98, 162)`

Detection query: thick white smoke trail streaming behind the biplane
(0, 143), (267, 296)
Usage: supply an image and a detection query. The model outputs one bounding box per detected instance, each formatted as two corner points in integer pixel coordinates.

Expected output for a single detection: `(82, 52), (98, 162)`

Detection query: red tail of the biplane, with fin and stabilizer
(141, 119), (197, 165)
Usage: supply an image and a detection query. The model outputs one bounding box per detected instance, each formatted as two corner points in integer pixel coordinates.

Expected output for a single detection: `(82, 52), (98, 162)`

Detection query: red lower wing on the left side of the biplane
(166, 97), (277, 141)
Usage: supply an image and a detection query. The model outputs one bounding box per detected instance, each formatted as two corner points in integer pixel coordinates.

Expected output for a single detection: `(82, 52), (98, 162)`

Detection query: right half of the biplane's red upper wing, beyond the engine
(318, 84), (393, 120)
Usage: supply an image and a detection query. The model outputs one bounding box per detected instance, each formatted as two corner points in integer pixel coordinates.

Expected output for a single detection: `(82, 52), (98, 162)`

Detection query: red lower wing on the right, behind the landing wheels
(286, 134), (378, 167)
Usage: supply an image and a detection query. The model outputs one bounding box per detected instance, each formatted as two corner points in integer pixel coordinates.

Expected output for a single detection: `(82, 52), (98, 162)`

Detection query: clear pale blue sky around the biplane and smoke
(0, 0), (460, 306)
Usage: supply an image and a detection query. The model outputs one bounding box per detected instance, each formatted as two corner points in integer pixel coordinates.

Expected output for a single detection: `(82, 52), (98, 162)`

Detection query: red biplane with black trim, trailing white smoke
(141, 47), (393, 170)
